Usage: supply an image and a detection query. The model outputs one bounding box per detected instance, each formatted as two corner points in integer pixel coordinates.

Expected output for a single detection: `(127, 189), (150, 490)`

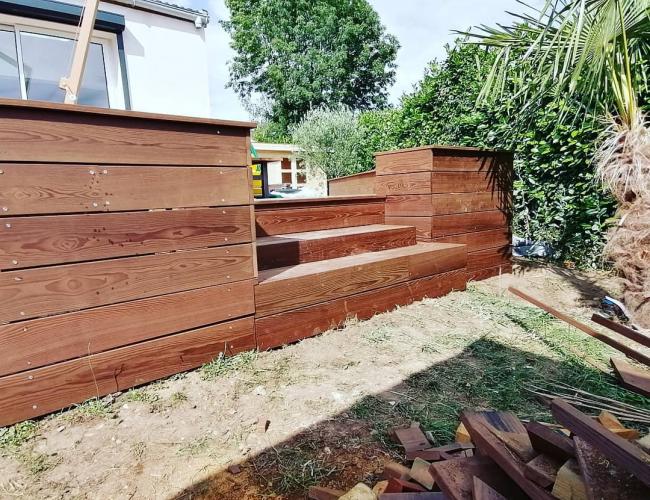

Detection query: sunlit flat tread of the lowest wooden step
(257, 242), (466, 287)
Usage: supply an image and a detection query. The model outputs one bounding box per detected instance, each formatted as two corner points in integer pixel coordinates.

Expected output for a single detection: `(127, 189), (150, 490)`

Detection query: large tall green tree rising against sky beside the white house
(222, 0), (399, 130)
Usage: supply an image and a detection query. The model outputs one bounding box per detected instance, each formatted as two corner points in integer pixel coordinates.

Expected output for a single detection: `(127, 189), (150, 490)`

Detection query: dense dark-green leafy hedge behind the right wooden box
(359, 44), (615, 266)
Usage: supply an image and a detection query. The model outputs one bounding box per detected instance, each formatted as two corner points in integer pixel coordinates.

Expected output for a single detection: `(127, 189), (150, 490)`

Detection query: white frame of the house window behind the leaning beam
(0, 14), (126, 109)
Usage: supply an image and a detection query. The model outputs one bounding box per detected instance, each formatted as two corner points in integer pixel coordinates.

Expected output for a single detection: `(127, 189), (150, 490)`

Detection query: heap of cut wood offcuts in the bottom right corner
(309, 398), (650, 500)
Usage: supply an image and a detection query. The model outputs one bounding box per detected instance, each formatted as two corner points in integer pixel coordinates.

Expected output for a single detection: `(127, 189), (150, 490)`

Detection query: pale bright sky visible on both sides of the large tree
(176, 0), (543, 120)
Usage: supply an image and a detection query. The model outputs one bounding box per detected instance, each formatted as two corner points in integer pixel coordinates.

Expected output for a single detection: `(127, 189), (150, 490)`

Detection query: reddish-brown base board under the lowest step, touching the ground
(255, 269), (467, 350)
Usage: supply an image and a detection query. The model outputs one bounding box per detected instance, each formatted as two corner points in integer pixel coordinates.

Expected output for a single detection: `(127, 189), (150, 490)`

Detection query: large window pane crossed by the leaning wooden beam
(20, 32), (109, 108)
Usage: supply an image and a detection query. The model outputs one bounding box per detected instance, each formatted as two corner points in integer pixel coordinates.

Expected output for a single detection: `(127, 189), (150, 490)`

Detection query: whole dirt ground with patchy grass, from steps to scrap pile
(0, 264), (647, 499)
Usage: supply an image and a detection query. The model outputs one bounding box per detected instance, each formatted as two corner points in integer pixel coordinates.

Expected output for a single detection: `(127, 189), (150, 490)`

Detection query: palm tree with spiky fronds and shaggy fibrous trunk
(464, 0), (650, 328)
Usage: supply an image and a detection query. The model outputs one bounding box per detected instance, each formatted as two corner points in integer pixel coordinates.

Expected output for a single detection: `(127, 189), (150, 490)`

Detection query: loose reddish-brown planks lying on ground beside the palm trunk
(508, 287), (650, 397)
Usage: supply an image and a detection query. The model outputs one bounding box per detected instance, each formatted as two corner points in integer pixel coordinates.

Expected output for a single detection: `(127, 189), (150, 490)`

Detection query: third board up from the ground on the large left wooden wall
(0, 244), (253, 322)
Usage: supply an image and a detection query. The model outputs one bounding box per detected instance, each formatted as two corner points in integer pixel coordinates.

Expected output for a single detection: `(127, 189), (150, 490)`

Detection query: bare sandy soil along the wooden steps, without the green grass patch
(0, 264), (636, 499)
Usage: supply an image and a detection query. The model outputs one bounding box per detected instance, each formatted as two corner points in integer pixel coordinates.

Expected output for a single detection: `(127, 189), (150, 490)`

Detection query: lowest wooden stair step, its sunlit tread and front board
(255, 243), (467, 317)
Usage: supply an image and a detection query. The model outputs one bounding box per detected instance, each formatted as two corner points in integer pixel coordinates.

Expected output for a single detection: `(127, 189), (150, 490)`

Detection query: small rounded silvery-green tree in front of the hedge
(292, 106), (367, 179)
